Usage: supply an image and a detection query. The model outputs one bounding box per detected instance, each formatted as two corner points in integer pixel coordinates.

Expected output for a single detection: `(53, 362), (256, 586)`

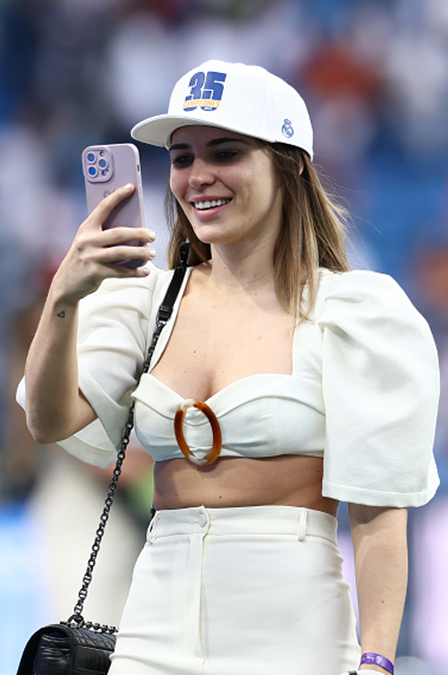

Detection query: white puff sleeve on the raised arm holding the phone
(17, 266), (160, 467)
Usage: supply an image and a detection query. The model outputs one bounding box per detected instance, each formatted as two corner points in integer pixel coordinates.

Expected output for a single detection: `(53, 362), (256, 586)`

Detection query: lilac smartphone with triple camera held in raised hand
(82, 143), (145, 268)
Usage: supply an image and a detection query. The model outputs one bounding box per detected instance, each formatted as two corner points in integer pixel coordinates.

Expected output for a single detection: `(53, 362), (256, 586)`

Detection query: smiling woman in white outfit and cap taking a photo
(19, 61), (438, 675)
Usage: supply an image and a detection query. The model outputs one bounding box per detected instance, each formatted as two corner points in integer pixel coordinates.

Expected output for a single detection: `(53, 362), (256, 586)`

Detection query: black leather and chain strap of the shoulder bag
(65, 243), (190, 634)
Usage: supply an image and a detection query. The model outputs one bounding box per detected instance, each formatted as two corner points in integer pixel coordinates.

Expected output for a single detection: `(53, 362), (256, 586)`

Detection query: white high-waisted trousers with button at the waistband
(109, 506), (360, 675)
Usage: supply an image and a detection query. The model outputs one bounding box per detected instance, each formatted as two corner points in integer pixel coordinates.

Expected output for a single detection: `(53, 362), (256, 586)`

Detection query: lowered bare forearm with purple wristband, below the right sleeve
(350, 504), (408, 672)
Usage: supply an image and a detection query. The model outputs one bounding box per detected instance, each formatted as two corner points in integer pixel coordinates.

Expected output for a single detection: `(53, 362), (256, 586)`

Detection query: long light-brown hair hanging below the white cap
(165, 143), (350, 321)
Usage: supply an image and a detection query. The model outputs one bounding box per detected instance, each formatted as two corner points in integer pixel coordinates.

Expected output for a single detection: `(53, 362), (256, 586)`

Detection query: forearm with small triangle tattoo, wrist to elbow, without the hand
(25, 283), (94, 443)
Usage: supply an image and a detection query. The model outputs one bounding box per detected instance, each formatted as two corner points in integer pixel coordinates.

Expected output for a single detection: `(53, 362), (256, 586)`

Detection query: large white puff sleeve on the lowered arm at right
(317, 271), (439, 507)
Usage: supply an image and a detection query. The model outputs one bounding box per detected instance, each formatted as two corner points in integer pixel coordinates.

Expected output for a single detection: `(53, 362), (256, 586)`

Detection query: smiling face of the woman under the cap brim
(170, 126), (282, 247)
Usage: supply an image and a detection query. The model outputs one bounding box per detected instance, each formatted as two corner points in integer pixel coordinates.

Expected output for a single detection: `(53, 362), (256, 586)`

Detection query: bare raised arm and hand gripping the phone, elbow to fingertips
(25, 186), (155, 443)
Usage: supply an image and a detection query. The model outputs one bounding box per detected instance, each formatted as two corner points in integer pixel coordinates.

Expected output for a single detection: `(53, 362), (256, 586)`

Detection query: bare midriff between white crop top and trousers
(154, 455), (338, 516)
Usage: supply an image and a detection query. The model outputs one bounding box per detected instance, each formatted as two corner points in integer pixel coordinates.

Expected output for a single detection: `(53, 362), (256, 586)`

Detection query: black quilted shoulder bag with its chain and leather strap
(17, 244), (188, 675)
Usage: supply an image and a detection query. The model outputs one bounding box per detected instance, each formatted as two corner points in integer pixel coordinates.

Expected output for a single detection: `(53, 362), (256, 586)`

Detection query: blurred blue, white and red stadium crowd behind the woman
(0, 0), (448, 675)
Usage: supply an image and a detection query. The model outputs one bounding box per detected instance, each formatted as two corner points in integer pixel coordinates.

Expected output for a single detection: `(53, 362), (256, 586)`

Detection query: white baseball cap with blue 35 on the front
(131, 60), (313, 158)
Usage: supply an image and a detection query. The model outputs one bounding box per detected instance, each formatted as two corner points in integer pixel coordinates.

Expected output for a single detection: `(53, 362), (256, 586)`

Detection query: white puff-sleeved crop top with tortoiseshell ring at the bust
(18, 266), (439, 507)
